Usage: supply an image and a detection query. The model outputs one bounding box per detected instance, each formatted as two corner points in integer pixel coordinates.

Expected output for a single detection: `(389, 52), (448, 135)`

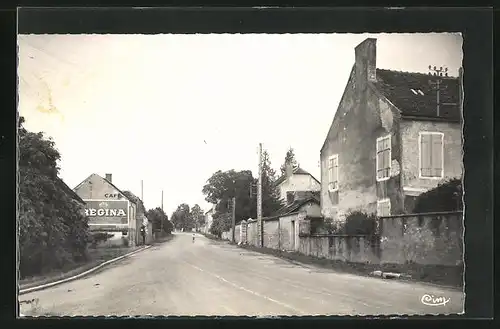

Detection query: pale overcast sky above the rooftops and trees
(18, 33), (466, 216)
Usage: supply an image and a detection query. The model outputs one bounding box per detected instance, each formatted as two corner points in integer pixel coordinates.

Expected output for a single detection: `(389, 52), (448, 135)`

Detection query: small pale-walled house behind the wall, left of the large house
(275, 165), (321, 203)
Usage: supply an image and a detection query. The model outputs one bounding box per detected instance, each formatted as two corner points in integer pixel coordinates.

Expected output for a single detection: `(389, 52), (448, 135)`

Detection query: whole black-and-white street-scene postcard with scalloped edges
(18, 26), (465, 317)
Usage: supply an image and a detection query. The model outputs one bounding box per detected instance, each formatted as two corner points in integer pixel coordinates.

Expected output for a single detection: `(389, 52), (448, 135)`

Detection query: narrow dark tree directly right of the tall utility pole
(262, 150), (283, 217)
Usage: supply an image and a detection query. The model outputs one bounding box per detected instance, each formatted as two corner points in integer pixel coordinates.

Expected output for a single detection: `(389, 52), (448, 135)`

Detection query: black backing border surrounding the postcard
(0, 8), (493, 326)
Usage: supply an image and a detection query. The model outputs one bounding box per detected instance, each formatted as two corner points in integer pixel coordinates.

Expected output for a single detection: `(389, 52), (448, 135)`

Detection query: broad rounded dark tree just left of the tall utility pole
(202, 170), (257, 229)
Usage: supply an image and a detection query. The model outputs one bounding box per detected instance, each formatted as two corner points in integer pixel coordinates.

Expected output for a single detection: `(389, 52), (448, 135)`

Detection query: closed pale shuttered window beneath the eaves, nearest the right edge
(418, 132), (444, 179)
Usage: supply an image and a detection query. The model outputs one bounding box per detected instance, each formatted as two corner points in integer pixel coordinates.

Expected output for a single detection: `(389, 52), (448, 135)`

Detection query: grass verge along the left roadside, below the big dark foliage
(19, 246), (142, 290)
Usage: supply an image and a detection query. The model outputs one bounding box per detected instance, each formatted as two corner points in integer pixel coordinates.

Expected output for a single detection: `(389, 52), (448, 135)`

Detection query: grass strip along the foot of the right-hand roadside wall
(239, 245), (463, 289)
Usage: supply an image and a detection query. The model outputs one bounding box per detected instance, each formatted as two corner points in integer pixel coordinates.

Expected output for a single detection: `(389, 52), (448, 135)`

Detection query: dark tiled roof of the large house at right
(374, 69), (461, 121)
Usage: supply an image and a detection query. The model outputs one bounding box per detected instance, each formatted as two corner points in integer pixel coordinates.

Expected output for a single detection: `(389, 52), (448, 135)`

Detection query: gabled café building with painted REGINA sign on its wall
(74, 174), (152, 247)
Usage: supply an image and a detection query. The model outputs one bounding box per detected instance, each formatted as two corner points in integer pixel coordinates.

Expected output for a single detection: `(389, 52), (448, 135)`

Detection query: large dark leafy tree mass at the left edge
(18, 117), (89, 277)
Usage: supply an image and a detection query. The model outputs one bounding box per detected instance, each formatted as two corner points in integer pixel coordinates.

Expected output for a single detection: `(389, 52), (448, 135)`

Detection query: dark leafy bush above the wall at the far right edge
(413, 178), (463, 213)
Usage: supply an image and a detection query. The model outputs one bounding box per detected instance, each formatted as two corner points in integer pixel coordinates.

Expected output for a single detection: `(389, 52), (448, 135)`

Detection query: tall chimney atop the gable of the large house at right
(354, 38), (377, 86)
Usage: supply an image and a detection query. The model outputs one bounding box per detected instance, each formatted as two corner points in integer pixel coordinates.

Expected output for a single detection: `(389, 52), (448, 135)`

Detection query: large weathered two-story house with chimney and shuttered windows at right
(320, 39), (463, 220)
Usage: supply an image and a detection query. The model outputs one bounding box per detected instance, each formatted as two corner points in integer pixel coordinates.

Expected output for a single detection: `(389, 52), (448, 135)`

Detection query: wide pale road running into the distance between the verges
(19, 233), (464, 316)
